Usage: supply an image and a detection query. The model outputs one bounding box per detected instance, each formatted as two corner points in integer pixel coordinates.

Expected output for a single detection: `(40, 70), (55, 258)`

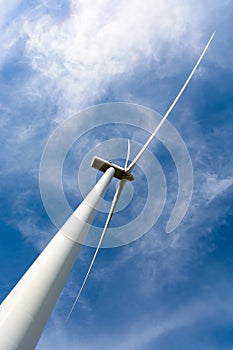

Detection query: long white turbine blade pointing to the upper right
(126, 32), (215, 173)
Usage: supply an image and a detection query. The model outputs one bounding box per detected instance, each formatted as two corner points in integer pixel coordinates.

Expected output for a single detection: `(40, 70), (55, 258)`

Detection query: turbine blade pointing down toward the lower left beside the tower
(66, 180), (126, 321)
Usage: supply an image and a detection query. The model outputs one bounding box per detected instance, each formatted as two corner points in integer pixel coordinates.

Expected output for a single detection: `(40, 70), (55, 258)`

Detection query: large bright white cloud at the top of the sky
(21, 0), (207, 117)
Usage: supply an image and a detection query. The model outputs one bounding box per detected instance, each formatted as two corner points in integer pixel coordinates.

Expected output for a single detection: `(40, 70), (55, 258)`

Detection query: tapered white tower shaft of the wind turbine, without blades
(0, 168), (115, 350)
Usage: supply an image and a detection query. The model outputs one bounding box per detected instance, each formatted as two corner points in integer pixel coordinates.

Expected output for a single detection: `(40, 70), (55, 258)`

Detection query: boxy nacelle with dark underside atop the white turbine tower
(91, 156), (134, 181)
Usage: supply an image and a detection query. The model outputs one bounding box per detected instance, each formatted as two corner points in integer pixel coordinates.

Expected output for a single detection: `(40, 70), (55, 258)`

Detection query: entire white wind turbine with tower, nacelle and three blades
(0, 33), (215, 350)
